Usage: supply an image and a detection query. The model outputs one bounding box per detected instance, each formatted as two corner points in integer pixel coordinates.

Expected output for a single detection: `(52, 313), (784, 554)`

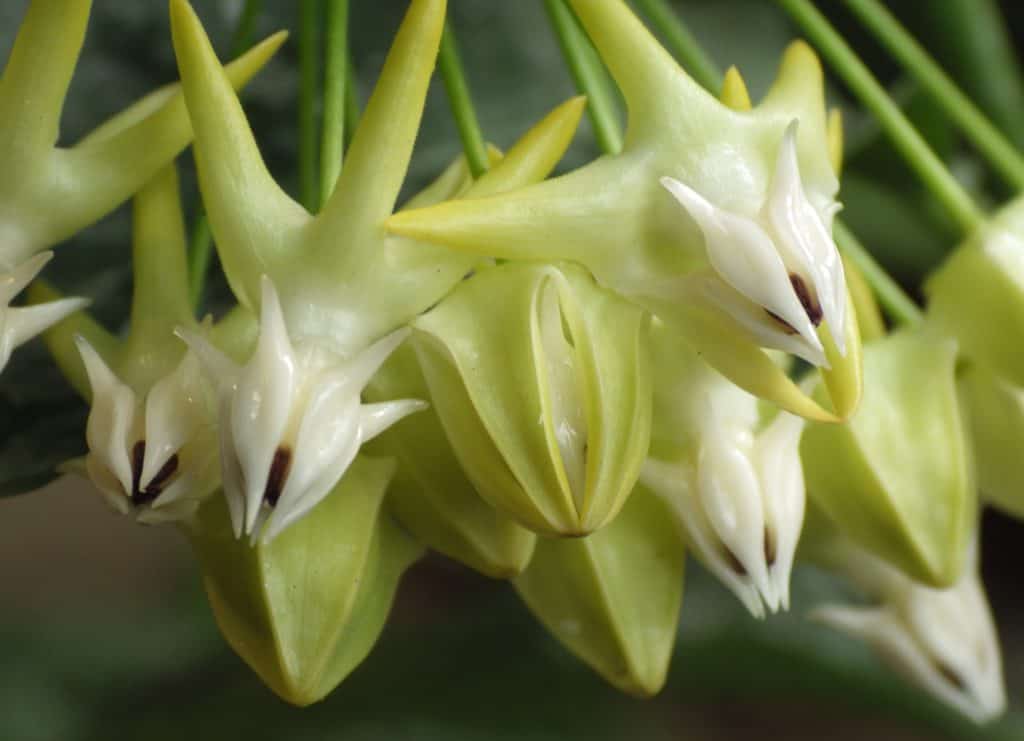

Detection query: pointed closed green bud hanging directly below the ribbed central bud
(515, 487), (685, 696)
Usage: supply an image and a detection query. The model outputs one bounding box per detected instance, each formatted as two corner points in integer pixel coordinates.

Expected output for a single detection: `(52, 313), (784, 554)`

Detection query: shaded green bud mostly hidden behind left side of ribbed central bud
(364, 344), (537, 578)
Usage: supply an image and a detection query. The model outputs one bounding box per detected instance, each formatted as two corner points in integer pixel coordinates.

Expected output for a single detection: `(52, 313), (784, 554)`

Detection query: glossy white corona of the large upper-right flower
(662, 121), (846, 365)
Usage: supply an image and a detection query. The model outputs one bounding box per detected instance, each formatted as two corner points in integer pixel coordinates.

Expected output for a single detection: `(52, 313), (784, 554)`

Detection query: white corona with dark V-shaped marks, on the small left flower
(76, 336), (218, 524)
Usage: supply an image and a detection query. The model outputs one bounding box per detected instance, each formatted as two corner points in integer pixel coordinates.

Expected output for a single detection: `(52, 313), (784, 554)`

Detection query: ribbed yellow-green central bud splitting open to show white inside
(413, 263), (651, 535)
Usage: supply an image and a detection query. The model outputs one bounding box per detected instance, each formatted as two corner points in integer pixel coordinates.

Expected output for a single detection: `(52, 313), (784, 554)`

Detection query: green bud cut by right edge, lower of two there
(958, 365), (1024, 518)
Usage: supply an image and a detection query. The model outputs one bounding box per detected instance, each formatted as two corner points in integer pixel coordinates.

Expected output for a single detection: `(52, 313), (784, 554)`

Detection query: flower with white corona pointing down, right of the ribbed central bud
(640, 325), (805, 617)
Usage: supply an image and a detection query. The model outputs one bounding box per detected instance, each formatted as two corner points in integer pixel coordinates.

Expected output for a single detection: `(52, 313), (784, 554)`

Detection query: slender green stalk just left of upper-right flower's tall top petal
(544, 0), (623, 155)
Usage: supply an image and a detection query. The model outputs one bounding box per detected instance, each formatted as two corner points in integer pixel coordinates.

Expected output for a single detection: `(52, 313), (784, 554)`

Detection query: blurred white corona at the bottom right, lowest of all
(812, 543), (1006, 723)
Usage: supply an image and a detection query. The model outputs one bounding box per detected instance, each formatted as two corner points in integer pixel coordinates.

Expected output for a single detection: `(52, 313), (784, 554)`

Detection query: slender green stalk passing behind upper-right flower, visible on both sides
(622, 0), (923, 324)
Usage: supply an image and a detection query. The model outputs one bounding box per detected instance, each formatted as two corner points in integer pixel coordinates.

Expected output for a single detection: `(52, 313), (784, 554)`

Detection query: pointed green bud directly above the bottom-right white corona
(801, 331), (976, 587)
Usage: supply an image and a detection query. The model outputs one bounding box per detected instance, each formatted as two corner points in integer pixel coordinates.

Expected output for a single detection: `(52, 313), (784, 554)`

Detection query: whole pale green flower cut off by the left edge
(0, 0), (284, 369)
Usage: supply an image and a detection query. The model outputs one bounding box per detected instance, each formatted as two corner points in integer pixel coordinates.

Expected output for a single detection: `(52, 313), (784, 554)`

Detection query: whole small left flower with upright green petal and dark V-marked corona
(30, 166), (235, 523)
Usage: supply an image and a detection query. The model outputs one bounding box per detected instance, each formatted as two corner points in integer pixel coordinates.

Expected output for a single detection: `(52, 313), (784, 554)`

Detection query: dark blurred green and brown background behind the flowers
(0, 0), (1024, 741)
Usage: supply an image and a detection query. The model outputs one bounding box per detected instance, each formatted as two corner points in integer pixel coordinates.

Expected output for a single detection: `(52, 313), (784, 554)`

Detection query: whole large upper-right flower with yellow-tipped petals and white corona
(388, 0), (859, 419)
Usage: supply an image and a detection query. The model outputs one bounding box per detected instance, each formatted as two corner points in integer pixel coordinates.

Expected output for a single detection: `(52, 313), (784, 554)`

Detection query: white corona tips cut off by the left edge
(0, 252), (89, 372)
